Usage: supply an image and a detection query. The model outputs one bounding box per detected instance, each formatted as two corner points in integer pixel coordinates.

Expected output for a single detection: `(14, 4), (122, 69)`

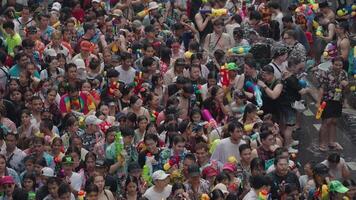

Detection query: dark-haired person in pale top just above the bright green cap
(321, 152), (350, 181)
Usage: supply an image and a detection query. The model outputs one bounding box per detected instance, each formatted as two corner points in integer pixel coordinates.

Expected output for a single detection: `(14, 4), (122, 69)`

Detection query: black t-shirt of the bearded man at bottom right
(268, 172), (300, 200)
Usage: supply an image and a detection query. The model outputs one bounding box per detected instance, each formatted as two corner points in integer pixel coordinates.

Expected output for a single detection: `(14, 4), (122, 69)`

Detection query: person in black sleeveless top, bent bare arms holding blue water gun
(257, 65), (283, 123)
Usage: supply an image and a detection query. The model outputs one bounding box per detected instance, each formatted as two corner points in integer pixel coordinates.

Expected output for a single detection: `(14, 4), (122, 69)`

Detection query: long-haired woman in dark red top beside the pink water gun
(203, 85), (228, 123)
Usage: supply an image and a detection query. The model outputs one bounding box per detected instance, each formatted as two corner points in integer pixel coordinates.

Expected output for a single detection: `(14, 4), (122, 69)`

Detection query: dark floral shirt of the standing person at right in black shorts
(316, 70), (348, 101)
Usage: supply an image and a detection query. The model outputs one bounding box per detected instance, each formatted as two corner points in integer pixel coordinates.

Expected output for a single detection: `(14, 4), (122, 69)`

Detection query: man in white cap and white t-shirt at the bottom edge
(143, 170), (172, 200)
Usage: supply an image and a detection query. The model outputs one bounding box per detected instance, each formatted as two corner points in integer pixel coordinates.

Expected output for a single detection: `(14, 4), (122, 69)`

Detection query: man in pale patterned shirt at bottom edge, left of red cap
(184, 164), (209, 199)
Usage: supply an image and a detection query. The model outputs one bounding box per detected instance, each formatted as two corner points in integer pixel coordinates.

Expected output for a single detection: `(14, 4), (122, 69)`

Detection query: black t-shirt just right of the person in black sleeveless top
(280, 75), (302, 106)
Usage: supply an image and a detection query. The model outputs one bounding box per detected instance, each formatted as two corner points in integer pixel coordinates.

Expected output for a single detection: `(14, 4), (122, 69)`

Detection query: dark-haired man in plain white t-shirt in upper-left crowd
(115, 52), (136, 85)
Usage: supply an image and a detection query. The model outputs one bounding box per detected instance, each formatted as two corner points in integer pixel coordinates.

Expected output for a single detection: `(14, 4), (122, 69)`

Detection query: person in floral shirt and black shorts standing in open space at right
(317, 57), (348, 151)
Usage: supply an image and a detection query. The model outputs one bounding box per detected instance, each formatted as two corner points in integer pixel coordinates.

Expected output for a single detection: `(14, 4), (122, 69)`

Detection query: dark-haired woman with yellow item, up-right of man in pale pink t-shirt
(240, 103), (262, 135)
